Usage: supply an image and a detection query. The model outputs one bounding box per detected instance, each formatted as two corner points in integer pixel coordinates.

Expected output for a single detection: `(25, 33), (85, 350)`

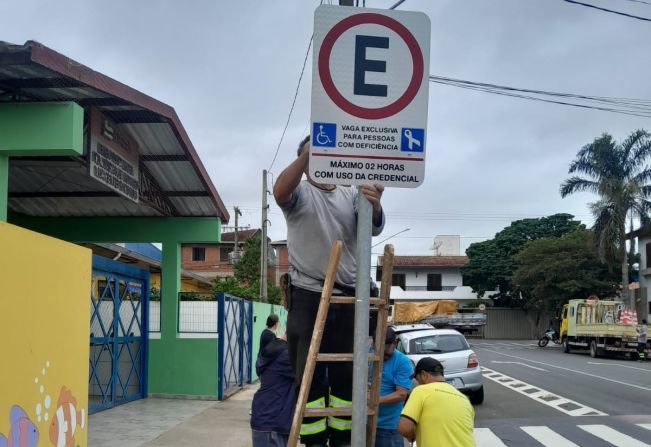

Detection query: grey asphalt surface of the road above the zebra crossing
(471, 340), (651, 421)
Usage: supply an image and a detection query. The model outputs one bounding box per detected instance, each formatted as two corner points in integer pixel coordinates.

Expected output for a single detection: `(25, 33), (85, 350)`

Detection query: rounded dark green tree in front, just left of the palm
(513, 228), (618, 317)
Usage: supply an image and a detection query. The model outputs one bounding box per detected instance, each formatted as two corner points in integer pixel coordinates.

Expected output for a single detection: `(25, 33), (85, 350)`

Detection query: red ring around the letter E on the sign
(319, 13), (424, 119)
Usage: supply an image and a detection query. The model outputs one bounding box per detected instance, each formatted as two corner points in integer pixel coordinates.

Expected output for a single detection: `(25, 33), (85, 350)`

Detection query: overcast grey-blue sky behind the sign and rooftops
(0, 0), (651, 263)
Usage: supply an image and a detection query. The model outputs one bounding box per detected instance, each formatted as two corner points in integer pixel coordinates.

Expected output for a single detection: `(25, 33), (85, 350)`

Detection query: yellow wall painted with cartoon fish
(0, 222), (92, 447)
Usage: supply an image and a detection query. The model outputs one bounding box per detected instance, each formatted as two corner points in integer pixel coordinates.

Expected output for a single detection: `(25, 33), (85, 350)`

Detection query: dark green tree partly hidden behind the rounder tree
(461, 214), (582, 306)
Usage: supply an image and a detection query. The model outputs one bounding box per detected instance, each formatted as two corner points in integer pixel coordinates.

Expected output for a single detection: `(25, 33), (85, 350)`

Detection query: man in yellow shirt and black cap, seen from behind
(398, 357), (475, 447)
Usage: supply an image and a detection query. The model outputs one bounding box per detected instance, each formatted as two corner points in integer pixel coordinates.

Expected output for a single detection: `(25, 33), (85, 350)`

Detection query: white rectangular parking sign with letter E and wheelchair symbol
(310, 5), (430, 188)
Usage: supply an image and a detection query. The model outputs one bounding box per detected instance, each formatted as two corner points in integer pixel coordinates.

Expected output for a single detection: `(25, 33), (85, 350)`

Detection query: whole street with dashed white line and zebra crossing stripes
(469, 340), (651, 447)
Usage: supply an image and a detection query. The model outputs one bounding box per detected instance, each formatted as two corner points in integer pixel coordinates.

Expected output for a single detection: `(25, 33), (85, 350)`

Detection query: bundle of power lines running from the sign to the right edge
(429, 75), (651, 118)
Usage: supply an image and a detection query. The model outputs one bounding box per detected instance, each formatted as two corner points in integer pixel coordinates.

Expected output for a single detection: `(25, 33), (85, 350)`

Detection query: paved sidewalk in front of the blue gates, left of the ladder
(88, 383), (259, 447)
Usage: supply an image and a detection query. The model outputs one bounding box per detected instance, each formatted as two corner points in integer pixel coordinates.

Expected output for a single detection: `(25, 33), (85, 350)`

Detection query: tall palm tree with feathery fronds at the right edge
(560, 130), (651, 307)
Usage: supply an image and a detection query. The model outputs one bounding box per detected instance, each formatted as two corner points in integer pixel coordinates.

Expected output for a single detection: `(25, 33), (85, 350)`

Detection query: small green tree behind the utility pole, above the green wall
(214, 236), (280, 304)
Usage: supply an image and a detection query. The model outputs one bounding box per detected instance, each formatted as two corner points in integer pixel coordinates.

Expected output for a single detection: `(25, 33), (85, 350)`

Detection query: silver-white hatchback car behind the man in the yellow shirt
(394, 325), (484, 405)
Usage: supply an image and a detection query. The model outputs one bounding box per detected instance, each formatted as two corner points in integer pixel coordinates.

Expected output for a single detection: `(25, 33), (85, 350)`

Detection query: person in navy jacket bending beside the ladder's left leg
(251, 336), (296, 447)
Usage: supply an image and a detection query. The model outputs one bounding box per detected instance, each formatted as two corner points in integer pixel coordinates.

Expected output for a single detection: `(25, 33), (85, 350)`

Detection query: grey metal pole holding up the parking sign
(351, 186), (373, 447)
